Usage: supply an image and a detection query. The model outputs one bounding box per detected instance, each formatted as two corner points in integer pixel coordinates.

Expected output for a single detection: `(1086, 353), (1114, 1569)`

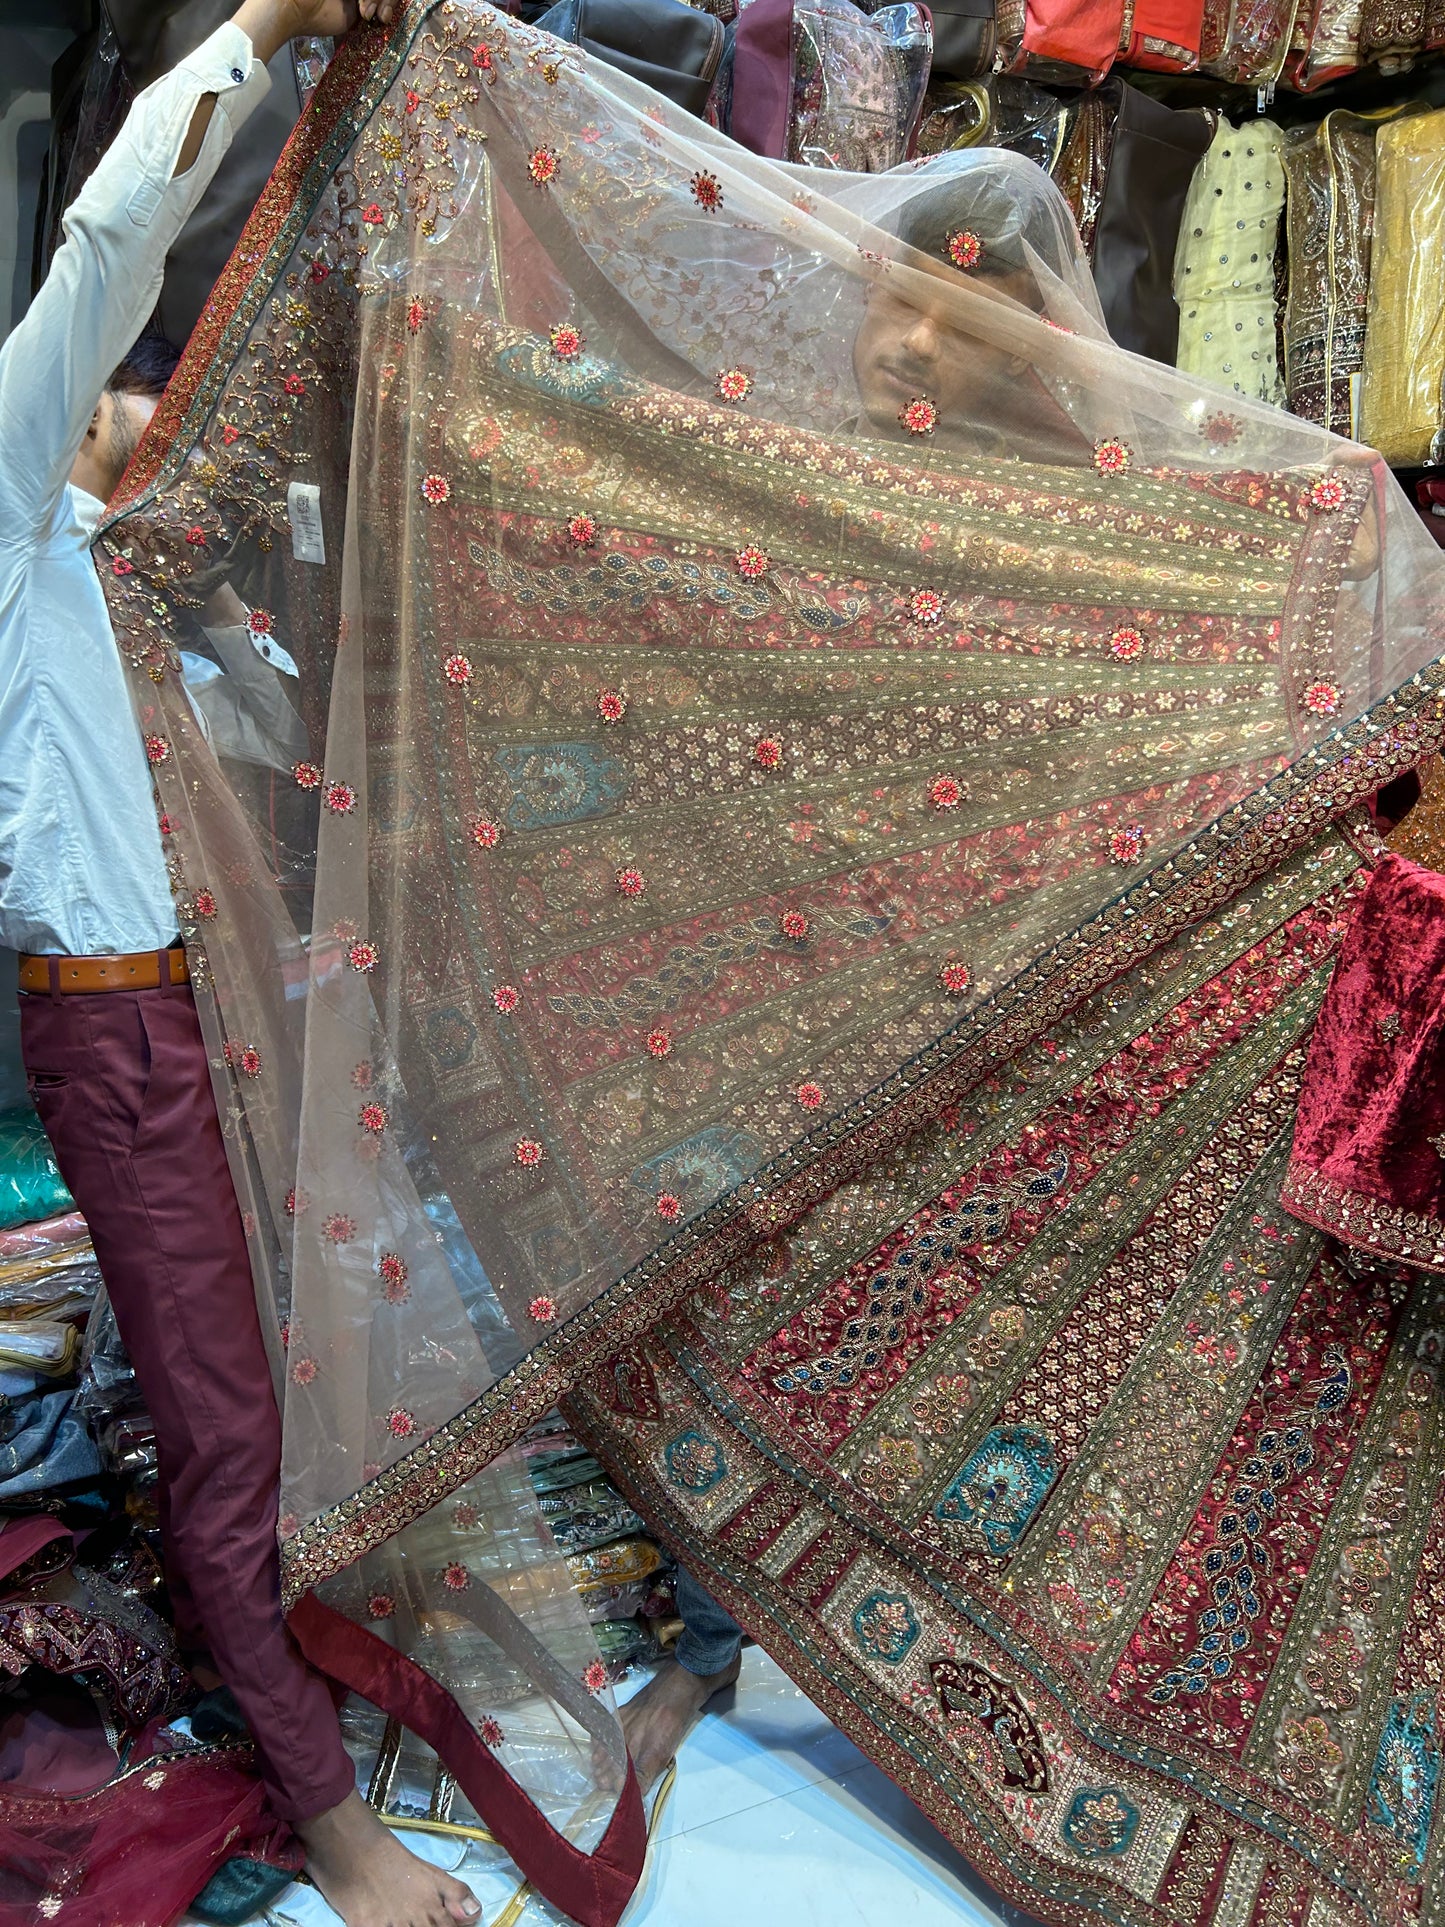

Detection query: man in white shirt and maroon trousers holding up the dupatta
(0, 0), (480, 1927)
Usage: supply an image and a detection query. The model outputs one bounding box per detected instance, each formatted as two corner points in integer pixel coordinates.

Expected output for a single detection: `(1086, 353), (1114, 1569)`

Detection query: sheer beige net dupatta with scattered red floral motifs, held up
(100, 4), (1439, 1917)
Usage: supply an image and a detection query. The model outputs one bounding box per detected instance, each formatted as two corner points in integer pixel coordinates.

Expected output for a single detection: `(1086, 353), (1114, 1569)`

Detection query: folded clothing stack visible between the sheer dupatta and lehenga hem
(520, 1412), (674, 1675)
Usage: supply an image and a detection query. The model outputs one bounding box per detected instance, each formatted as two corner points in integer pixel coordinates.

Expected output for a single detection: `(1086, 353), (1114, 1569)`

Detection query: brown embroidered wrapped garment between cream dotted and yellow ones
(1281, 114), (1410, 436)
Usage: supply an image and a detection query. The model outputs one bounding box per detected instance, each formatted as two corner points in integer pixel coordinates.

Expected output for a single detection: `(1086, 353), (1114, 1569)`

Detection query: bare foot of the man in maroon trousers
(295, 1794), (482, 1927)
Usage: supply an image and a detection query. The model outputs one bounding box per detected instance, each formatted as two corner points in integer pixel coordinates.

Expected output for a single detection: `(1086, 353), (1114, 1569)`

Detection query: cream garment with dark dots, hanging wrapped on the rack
(1173, 119), (1285, 401)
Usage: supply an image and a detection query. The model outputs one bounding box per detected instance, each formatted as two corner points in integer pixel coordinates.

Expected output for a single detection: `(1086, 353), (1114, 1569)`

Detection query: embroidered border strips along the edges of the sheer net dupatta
(84, 0), (1445, 1605)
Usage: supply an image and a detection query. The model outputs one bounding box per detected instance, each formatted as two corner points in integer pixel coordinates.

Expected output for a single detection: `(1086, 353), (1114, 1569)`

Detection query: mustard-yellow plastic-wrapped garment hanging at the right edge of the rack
(1360, 112), (1445, 466)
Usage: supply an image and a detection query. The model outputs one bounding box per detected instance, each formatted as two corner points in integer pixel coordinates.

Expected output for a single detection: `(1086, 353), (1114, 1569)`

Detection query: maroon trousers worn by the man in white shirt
(19, 985), (355, 1821)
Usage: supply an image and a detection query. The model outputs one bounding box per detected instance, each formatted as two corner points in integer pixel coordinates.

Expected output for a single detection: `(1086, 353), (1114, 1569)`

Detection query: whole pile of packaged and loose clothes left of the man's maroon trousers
(0, 1106), (232, 1927)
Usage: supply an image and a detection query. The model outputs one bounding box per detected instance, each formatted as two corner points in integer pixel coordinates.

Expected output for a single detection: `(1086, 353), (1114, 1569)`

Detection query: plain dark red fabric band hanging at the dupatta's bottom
(287, 1594), (647, 1927)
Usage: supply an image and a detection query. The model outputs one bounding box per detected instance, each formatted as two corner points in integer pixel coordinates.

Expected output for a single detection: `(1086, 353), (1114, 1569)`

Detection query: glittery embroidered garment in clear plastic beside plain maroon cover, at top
(788, 0), (933, 173)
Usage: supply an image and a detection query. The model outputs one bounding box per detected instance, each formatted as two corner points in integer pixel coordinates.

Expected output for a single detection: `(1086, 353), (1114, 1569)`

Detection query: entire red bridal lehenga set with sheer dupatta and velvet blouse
(78, 0), (1445, 1927)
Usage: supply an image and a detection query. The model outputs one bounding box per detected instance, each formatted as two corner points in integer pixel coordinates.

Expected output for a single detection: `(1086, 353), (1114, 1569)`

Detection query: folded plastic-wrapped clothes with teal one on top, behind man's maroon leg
(0, 1106), (106, 1522)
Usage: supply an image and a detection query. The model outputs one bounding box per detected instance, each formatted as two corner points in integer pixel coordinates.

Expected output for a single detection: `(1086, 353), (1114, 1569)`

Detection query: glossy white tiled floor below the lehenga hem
(237, 1648), (1021, 1927)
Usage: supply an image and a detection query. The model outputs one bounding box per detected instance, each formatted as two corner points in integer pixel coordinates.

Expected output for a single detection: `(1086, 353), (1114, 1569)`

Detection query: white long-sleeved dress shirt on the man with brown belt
(0, 25), (270, 956)
